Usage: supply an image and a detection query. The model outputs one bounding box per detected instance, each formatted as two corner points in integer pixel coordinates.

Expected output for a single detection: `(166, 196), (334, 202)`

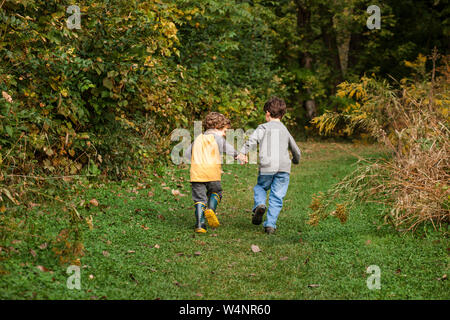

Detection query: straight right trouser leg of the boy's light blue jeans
(264, 172), (289, 229)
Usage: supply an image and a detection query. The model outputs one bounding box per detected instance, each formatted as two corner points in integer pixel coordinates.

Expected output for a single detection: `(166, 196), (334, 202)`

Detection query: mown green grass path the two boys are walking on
(0, 143), (450, 299)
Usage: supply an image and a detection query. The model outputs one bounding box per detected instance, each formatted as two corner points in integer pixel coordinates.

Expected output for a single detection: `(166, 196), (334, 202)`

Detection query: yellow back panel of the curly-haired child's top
(190, 134), (222, 182)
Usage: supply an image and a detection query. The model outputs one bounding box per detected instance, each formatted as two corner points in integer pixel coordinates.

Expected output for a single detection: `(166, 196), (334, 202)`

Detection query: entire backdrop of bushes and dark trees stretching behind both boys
(0, 0), (447, 189)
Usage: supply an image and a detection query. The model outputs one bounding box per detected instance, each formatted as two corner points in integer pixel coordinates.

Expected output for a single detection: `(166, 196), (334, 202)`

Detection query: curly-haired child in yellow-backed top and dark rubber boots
(186, 112), (247, 233)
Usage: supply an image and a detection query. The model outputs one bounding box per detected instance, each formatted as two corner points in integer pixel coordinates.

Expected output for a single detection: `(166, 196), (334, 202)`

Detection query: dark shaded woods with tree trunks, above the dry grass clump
(260, 0), (449, 127)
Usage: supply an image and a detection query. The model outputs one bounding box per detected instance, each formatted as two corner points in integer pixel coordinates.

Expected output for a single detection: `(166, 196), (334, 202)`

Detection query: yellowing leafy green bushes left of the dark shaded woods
(0, 0), (292, 189)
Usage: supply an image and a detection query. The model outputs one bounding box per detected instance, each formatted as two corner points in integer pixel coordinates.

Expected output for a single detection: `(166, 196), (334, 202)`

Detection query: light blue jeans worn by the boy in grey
(253, 172), (289, 229)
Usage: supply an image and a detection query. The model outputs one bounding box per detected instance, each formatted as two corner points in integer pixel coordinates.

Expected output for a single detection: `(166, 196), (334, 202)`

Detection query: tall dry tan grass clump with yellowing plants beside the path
(309, 52), (450, 231)
